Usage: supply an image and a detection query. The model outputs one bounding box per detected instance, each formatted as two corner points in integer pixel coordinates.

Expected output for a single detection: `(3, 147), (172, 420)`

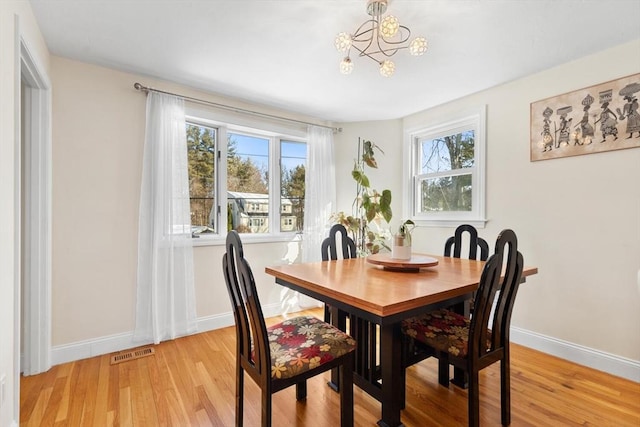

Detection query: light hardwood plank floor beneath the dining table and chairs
(20, 311), (640, 427)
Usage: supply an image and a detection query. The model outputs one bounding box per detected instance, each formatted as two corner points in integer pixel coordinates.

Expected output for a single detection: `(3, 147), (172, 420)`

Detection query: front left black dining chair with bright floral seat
(222, 230), (356, 427)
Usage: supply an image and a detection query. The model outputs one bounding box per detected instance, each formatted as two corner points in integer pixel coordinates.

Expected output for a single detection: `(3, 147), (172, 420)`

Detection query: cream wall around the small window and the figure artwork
(336, 40), (640, 381)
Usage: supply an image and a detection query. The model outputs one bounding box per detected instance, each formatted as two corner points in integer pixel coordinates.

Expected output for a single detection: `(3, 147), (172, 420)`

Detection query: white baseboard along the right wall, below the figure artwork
(510, 326), (640, 383)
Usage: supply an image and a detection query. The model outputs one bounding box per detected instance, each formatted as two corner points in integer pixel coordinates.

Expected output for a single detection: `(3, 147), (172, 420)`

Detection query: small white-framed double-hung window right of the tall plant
(405, 107), (485, 226)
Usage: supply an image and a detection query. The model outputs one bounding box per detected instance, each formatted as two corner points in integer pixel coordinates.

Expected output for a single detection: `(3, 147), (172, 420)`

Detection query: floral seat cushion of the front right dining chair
(402, 309), (491, 358)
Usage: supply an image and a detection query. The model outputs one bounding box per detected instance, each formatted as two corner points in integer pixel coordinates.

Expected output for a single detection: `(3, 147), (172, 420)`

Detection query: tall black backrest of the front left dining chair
(222, 230), (271, 383)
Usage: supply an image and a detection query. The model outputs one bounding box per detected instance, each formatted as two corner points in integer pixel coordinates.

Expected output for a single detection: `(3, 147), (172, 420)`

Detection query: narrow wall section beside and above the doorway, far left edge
(0, 1), (49, 427)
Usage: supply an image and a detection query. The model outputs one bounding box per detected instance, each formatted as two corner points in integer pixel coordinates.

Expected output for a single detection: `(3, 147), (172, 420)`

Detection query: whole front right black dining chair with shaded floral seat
(401, 230), (523, 426)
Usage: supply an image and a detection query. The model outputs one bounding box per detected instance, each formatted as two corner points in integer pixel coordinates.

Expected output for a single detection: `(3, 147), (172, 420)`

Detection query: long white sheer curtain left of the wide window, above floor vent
(134, 92), (196, 344)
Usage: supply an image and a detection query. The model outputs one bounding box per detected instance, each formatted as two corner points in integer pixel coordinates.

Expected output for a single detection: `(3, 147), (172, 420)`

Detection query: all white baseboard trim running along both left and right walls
(51, 310), (640, 383)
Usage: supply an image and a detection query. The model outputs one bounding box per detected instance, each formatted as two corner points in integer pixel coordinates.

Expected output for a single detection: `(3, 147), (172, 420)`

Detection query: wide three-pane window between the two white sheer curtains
(186, 119), (307, 241)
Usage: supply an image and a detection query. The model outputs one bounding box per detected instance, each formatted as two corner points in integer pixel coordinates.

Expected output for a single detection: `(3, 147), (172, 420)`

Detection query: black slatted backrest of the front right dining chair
(469, 230), (524, 359)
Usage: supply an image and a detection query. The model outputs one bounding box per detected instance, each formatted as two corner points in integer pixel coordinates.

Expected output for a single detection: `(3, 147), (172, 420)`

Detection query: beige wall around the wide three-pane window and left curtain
(52, 56), (322, 352)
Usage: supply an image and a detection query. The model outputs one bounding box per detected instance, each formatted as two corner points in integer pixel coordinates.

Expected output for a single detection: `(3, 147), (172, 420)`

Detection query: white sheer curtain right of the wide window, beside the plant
(302, 126), (336, 262)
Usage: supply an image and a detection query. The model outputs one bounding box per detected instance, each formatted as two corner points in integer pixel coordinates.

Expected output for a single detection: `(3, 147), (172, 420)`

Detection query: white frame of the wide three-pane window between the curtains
(185, 108), (308, 246)
